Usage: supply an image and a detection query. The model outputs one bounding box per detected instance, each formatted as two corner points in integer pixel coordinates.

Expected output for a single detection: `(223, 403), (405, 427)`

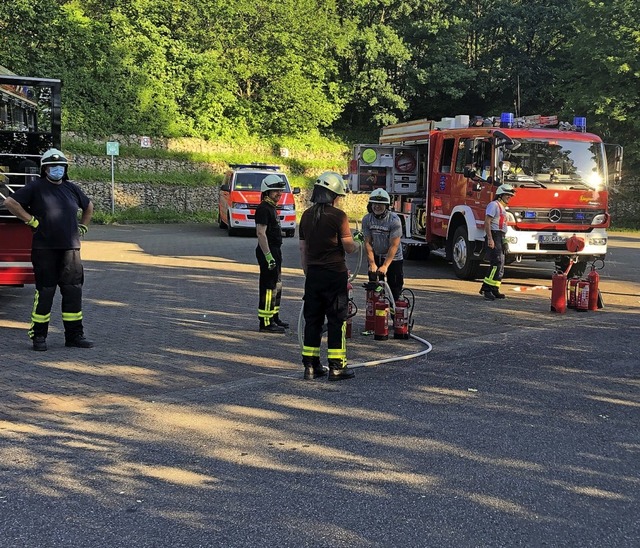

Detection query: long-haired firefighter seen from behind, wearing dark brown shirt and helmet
(299, 171), (363, 381)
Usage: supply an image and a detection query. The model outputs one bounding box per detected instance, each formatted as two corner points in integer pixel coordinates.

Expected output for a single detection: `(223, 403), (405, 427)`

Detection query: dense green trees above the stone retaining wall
(0, 0), (640, 165)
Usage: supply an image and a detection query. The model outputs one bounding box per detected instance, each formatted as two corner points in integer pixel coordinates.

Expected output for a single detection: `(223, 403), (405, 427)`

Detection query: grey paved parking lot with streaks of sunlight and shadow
(0, 225), (640, 548)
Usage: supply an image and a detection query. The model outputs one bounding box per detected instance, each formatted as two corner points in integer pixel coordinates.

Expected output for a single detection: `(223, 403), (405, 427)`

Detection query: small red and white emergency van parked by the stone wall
(218, 164), (300, 238)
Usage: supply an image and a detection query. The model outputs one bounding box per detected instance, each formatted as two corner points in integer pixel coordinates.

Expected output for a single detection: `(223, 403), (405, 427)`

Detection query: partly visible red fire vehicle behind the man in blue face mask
(0, 71), (62, 286)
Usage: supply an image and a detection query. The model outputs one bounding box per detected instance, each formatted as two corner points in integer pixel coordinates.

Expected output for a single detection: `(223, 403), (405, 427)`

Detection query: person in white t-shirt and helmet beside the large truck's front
(480, 184), (516, 301)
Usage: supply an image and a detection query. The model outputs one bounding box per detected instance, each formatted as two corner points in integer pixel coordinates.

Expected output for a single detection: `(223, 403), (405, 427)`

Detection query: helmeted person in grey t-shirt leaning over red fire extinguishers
(362, 188), (404, 301)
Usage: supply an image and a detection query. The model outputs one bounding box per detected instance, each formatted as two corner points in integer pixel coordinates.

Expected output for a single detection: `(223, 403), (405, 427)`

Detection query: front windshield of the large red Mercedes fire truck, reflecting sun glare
(500, 139), (607, 190)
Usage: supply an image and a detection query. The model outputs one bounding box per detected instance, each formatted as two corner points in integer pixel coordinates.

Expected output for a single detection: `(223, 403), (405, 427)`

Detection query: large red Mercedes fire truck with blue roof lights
(349, 113), (623, 280)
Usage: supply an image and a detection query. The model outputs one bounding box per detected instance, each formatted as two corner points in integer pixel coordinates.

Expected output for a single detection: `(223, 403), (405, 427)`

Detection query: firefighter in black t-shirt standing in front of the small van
(255, 174), (289, 333)
